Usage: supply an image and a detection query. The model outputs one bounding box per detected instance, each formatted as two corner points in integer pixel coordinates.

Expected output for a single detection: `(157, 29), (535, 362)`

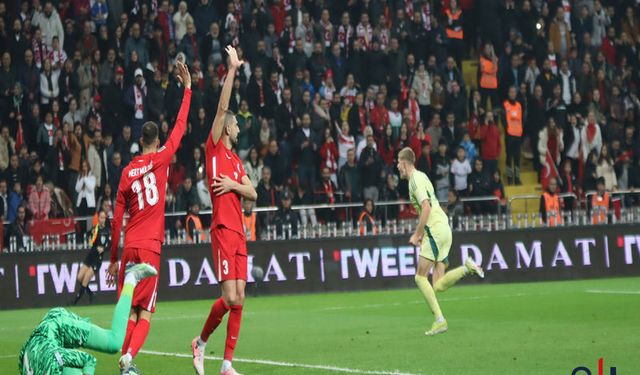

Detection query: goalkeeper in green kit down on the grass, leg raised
(18, 263), (158, 375)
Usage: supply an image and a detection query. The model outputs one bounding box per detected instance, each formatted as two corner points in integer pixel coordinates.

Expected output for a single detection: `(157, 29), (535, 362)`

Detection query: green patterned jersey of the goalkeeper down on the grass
(18, 308), (96, 375)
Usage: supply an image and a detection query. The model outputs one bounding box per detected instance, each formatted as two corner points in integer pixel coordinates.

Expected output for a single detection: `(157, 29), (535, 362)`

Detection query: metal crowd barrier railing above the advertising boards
(5, 194), (640, 252)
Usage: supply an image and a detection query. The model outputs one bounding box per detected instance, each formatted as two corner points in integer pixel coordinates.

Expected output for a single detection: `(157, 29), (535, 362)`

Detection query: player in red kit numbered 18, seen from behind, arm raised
(108, 62), (191, 374)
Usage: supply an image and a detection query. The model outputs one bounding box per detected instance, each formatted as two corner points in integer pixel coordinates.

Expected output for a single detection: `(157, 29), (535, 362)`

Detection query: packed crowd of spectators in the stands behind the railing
(0, 0), (640, 241)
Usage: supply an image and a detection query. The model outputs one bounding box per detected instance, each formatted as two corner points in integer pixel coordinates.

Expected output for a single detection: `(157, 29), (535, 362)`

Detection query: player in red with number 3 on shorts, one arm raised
(191, 46), (257, 375)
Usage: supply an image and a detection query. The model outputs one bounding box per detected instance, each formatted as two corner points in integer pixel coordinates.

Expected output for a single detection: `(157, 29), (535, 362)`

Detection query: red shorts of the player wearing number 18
(118, 247), (160, 312)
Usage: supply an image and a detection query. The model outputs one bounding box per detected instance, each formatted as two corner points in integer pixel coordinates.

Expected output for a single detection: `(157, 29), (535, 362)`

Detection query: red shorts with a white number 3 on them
(211, 227), (247, 282)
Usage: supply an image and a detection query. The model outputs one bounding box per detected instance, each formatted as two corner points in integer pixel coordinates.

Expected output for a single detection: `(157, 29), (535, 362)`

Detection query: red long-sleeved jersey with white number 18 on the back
(111, 88), (191, 263)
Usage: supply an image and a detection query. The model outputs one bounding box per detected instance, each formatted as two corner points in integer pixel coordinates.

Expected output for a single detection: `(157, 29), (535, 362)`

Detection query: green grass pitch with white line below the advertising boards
(0, 278), (640, 375)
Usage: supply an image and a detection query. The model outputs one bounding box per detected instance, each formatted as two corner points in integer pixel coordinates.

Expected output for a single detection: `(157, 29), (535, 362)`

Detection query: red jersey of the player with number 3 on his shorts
(205, 135), (246, 236)
